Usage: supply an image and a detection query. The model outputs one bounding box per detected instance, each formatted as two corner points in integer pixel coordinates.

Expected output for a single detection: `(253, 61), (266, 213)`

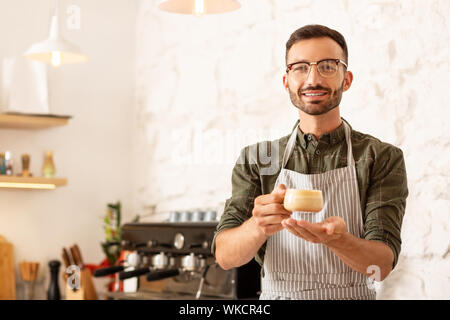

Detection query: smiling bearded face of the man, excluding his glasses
(283, 37), (353, 115)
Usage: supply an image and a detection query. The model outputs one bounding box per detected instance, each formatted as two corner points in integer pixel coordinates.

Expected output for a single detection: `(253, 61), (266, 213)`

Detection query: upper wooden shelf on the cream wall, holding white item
(0, 112), (71, 130)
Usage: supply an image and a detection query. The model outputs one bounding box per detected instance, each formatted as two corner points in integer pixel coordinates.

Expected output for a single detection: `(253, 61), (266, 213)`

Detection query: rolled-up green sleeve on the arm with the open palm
(364, 145), (408, 267)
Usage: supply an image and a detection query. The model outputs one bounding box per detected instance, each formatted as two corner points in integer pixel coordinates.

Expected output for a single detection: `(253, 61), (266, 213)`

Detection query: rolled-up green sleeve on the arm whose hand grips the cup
(211, 147), (261, 255)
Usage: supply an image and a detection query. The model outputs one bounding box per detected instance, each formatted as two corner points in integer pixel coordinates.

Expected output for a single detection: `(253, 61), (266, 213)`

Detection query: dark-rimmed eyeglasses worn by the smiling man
(286, 59), (347, 79)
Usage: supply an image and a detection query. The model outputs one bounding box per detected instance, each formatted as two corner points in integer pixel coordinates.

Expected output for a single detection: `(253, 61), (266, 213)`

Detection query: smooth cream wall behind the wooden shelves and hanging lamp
(0, 0), (136, 299)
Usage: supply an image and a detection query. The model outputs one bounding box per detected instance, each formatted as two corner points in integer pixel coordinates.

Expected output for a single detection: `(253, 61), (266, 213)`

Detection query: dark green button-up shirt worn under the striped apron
(212, 119), (408, 266)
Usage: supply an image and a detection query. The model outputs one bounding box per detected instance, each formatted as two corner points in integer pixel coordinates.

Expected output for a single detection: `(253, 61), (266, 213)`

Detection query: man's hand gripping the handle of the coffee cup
(252, 184), (292, 237)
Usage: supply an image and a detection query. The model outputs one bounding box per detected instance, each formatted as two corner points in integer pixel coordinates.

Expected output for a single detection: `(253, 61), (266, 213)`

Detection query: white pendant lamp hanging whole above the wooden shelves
(24, 1), (88, 67)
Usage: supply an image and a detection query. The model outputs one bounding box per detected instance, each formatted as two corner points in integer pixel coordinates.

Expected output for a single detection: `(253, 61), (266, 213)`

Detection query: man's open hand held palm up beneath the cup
(281, 217), (347, 245)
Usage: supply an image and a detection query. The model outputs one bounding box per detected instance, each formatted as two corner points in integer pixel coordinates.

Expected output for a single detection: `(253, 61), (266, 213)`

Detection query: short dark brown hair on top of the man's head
(286, 24), (348, 64)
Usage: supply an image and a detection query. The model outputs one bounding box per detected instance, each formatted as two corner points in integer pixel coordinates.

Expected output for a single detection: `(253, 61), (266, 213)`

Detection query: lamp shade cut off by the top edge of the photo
(158, 0), (241, 15)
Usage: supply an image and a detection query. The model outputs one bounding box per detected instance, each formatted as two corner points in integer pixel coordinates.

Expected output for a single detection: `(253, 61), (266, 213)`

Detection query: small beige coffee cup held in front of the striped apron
(284, 189), (323, 213)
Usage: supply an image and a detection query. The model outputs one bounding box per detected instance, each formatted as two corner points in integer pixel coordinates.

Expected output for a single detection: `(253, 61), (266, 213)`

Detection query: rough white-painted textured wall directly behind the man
(132, 0), (450, 299)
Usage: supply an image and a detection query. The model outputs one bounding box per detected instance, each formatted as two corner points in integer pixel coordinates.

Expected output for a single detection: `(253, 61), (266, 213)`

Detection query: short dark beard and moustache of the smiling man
(289, 81), (345, 116)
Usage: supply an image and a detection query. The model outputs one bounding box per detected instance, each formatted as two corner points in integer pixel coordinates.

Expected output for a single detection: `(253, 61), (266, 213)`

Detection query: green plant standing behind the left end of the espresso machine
(101, 201), (121, 265)
